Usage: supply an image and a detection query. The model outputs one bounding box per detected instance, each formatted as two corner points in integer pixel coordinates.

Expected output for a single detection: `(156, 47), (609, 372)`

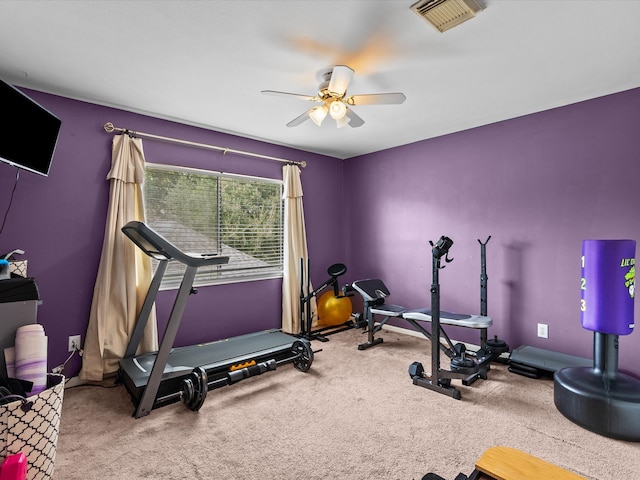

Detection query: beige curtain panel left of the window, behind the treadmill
(80, 134), (158, 381)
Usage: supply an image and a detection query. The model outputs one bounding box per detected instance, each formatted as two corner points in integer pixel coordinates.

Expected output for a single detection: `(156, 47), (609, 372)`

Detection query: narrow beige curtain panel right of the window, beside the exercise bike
(282, 165), (316, 334)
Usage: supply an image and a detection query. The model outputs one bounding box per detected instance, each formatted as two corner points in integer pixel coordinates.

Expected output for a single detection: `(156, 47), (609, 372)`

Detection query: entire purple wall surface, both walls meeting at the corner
(0, 89), (640, 374)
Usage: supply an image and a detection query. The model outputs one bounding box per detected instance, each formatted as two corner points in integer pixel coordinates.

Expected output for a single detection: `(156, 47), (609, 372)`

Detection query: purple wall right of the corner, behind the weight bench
(344, 89), (640, 374)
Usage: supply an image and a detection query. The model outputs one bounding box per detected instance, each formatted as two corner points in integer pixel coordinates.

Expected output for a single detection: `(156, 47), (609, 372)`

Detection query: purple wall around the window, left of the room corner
(0, 90), (344, 374)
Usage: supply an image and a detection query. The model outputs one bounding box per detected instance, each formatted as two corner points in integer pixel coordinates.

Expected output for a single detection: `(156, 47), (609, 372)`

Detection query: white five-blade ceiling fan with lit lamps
(262, 65), (406, 128)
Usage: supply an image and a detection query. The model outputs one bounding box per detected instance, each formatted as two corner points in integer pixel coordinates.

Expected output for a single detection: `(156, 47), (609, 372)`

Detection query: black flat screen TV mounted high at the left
(0, 80), (62, 177)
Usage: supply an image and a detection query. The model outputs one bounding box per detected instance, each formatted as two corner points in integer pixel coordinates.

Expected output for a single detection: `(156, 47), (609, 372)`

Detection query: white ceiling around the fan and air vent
(0, 0), (640, 158)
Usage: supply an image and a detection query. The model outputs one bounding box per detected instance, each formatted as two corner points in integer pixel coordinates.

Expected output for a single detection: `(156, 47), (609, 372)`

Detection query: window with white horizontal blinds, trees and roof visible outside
(143, 163), (284, 289)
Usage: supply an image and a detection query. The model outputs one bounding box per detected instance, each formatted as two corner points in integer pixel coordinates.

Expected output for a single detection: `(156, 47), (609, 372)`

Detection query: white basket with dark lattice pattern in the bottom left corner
(0, 374), (64, 480)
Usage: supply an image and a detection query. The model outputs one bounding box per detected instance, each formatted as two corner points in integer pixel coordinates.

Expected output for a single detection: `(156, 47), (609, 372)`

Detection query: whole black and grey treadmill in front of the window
(119, 221), (313, 418)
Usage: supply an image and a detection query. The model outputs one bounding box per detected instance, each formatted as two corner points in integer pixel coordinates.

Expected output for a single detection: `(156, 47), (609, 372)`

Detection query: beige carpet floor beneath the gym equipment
(54, 330), (640, 480)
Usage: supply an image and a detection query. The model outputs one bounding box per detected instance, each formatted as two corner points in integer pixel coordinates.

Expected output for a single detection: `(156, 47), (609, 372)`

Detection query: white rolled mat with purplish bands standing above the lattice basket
(15, 323), (48, 395)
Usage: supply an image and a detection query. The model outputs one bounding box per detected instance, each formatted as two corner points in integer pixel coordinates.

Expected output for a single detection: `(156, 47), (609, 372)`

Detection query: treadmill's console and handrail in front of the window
(122, 220), (229, 267)
